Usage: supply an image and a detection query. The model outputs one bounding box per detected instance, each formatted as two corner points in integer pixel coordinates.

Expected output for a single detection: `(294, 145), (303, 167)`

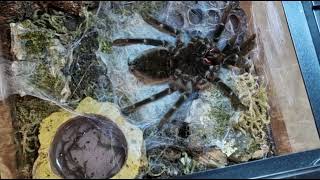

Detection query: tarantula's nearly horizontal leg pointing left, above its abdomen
(112, 39), (170, 47)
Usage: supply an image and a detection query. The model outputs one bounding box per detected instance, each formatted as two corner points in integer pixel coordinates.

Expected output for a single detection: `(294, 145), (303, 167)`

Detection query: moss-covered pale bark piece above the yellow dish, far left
(15, 15), (66, 98)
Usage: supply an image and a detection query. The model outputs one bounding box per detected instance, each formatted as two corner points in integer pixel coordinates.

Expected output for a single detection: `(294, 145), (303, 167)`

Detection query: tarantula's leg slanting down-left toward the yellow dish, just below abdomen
(121, 88), (175, 114)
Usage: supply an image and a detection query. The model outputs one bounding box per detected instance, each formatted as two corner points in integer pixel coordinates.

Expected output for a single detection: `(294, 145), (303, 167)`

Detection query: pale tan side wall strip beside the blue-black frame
(241, 1), (320, 154)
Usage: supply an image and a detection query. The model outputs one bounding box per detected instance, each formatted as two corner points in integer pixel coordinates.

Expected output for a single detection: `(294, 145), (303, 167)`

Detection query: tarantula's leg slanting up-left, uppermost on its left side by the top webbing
(141, 13), (180, 37)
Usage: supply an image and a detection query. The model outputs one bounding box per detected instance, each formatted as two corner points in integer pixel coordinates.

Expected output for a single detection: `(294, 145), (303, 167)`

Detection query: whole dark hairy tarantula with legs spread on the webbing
(113, 3), (255, 129)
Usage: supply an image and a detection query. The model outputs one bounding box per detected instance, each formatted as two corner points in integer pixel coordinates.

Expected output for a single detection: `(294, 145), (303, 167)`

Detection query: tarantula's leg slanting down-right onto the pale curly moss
(212, 77), (248, 110)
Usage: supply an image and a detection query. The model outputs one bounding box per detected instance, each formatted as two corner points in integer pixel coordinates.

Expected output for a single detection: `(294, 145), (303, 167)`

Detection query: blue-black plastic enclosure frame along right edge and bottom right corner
(181, 1), (320, 179)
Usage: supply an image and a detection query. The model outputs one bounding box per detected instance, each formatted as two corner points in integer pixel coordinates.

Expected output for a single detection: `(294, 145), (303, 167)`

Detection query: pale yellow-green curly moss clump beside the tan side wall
(235, 73), (270, 145)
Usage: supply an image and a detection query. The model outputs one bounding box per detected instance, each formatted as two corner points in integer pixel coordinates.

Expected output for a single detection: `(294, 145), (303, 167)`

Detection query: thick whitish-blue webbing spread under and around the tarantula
(5, 1), (270, 178)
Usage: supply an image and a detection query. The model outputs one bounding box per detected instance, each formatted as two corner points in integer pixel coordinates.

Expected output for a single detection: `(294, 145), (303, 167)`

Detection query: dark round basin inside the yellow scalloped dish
(49, 115), (128, 179)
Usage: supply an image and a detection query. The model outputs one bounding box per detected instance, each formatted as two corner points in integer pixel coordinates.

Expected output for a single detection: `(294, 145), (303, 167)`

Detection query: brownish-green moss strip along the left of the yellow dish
(13, 96), (60, 178)
